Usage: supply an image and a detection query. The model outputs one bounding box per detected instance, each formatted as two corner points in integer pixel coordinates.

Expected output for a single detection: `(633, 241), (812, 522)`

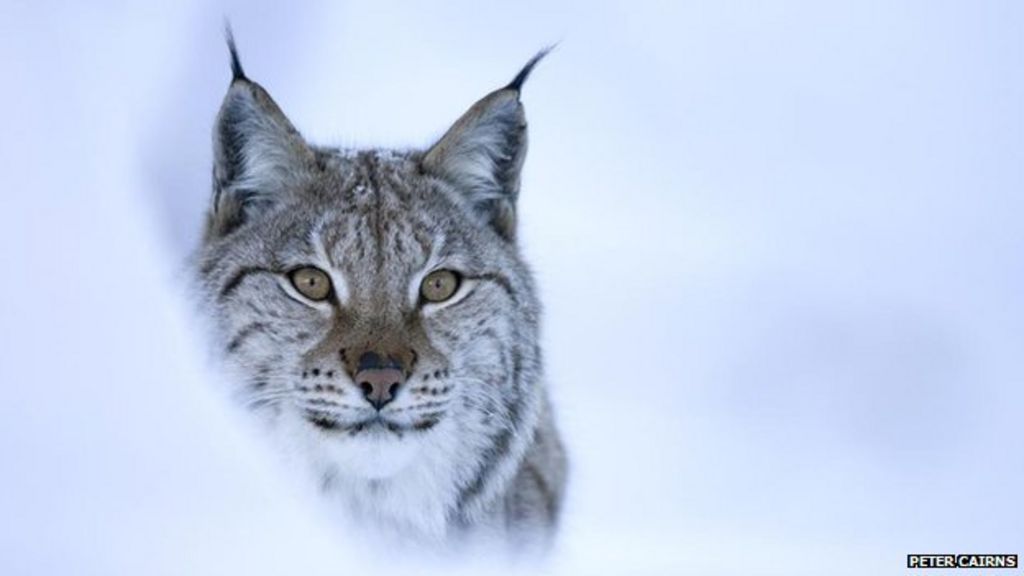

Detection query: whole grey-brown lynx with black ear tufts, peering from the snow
(196, 34), (566, 547)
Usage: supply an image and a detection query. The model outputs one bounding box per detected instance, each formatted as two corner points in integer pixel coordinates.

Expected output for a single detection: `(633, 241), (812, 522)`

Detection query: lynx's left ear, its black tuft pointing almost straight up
(207, 30), (314, 236)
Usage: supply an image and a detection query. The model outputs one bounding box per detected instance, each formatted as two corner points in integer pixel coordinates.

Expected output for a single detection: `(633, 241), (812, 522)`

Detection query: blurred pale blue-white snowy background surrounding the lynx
(0, 1), (1024, 575)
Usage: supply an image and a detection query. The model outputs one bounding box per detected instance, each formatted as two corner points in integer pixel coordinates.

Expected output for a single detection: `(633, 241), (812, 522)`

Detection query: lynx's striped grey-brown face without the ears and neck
(195, 146), (538, 461)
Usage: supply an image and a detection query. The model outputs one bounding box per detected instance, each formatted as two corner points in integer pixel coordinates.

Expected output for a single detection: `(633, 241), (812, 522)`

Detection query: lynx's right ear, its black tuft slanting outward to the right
(423, 48), (550, 240)
